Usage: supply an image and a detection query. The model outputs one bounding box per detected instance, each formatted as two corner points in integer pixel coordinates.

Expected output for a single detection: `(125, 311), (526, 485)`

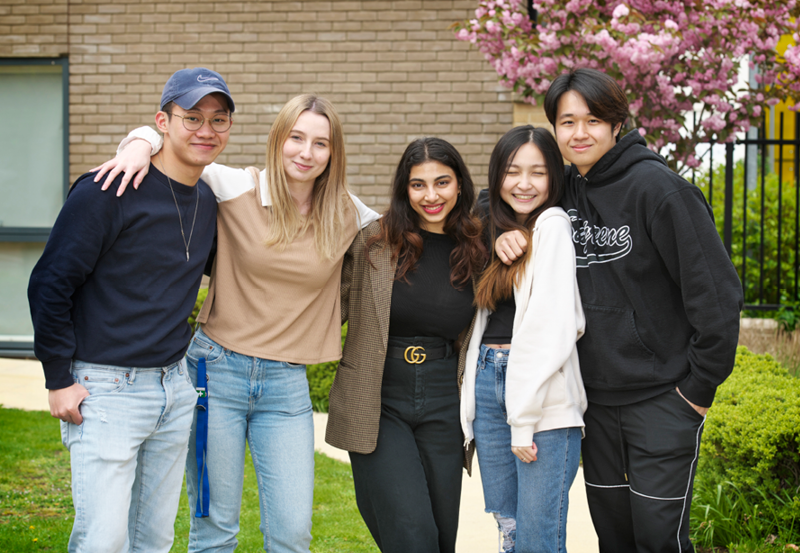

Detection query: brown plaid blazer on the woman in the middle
(325, 221), (475, 472)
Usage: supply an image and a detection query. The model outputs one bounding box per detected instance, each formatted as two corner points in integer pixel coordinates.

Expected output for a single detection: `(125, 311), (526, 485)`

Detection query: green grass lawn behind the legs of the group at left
(0, 408), (378, 553)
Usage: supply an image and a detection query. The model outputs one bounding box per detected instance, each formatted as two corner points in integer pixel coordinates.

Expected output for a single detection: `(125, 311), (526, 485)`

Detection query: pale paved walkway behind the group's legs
(0, 358), (598, 553)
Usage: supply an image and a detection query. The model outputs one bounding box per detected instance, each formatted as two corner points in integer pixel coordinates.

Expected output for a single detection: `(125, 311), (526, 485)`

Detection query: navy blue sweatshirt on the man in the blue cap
(28, 164), (217, 390)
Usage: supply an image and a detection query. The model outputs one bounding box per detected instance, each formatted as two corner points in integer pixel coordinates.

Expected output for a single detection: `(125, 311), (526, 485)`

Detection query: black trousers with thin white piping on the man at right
(582, 389), (705, 553)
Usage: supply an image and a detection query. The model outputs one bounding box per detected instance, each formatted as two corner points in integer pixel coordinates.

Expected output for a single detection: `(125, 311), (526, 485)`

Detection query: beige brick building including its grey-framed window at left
(0, 0), (548, 353)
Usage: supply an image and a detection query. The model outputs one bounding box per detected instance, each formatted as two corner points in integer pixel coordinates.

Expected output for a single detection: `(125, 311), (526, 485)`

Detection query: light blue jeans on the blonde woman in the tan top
(186, 330), (314, 553)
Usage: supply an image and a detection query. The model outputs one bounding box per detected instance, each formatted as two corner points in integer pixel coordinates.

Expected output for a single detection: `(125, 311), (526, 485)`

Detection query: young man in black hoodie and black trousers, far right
(500, 69), (743, 553)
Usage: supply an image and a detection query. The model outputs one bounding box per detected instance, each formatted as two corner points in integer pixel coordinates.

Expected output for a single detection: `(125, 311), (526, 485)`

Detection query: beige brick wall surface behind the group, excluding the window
(0, 0), (513, 208)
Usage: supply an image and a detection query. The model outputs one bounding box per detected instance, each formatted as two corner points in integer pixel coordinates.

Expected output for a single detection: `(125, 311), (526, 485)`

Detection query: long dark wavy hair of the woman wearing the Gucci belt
(367, 137), (487, 289)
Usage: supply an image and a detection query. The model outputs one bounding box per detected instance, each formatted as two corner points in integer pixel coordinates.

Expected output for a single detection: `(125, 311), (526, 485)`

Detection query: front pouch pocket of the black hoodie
(578, 304), (656, 390)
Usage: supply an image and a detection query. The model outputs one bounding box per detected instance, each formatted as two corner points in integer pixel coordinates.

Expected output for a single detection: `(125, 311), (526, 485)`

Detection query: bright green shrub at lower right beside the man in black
(692, 347), (800, 546)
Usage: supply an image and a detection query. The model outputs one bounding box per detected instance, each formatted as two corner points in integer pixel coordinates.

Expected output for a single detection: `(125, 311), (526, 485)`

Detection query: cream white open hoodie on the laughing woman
(461, 207), (587, 447)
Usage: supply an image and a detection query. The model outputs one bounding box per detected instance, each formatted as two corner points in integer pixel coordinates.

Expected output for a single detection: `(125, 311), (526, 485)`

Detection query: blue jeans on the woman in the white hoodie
(473, 345), (581, 553)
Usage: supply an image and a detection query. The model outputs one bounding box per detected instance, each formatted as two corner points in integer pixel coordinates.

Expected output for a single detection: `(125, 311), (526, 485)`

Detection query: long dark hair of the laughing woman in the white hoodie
(475, 125), (564, 310)
